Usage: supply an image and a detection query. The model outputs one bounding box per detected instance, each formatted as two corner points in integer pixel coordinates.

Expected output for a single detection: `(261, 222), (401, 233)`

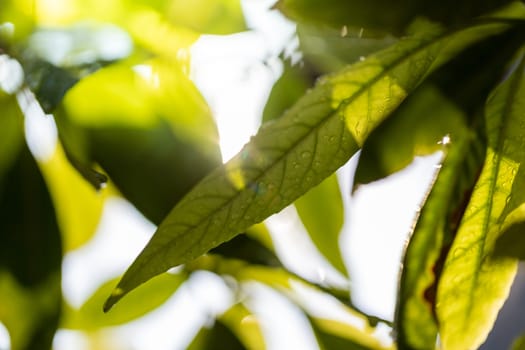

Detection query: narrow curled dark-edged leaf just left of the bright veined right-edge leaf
(395, 126), (485, 349)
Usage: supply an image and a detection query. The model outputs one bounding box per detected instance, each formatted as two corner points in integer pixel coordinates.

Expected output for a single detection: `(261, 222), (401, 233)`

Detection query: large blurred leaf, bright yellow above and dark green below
(57, 60), (220, 224)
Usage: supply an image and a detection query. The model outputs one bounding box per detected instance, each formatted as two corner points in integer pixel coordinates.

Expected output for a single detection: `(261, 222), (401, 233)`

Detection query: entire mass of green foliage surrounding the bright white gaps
(0, 0), (525, 350)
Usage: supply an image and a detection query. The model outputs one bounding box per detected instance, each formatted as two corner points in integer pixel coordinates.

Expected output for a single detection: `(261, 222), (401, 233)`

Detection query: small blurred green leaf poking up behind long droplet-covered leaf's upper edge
(263, 59), (316, 122)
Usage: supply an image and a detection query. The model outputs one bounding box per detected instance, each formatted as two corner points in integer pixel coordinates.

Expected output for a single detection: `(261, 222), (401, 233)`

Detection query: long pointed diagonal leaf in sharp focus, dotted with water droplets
(105, 21), (509, 310)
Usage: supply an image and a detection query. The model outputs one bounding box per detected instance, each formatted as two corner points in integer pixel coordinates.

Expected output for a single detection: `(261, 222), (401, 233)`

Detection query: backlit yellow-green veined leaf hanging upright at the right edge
(436, 50), (525, 349)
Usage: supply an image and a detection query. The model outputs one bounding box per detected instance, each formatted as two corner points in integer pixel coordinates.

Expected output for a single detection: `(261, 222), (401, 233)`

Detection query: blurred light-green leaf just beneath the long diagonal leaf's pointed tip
(61, 272), (186, 331)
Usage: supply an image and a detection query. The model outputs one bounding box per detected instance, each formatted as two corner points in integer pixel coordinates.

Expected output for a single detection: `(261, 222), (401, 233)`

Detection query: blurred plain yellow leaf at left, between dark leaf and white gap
(40, 146), (107, 252)
